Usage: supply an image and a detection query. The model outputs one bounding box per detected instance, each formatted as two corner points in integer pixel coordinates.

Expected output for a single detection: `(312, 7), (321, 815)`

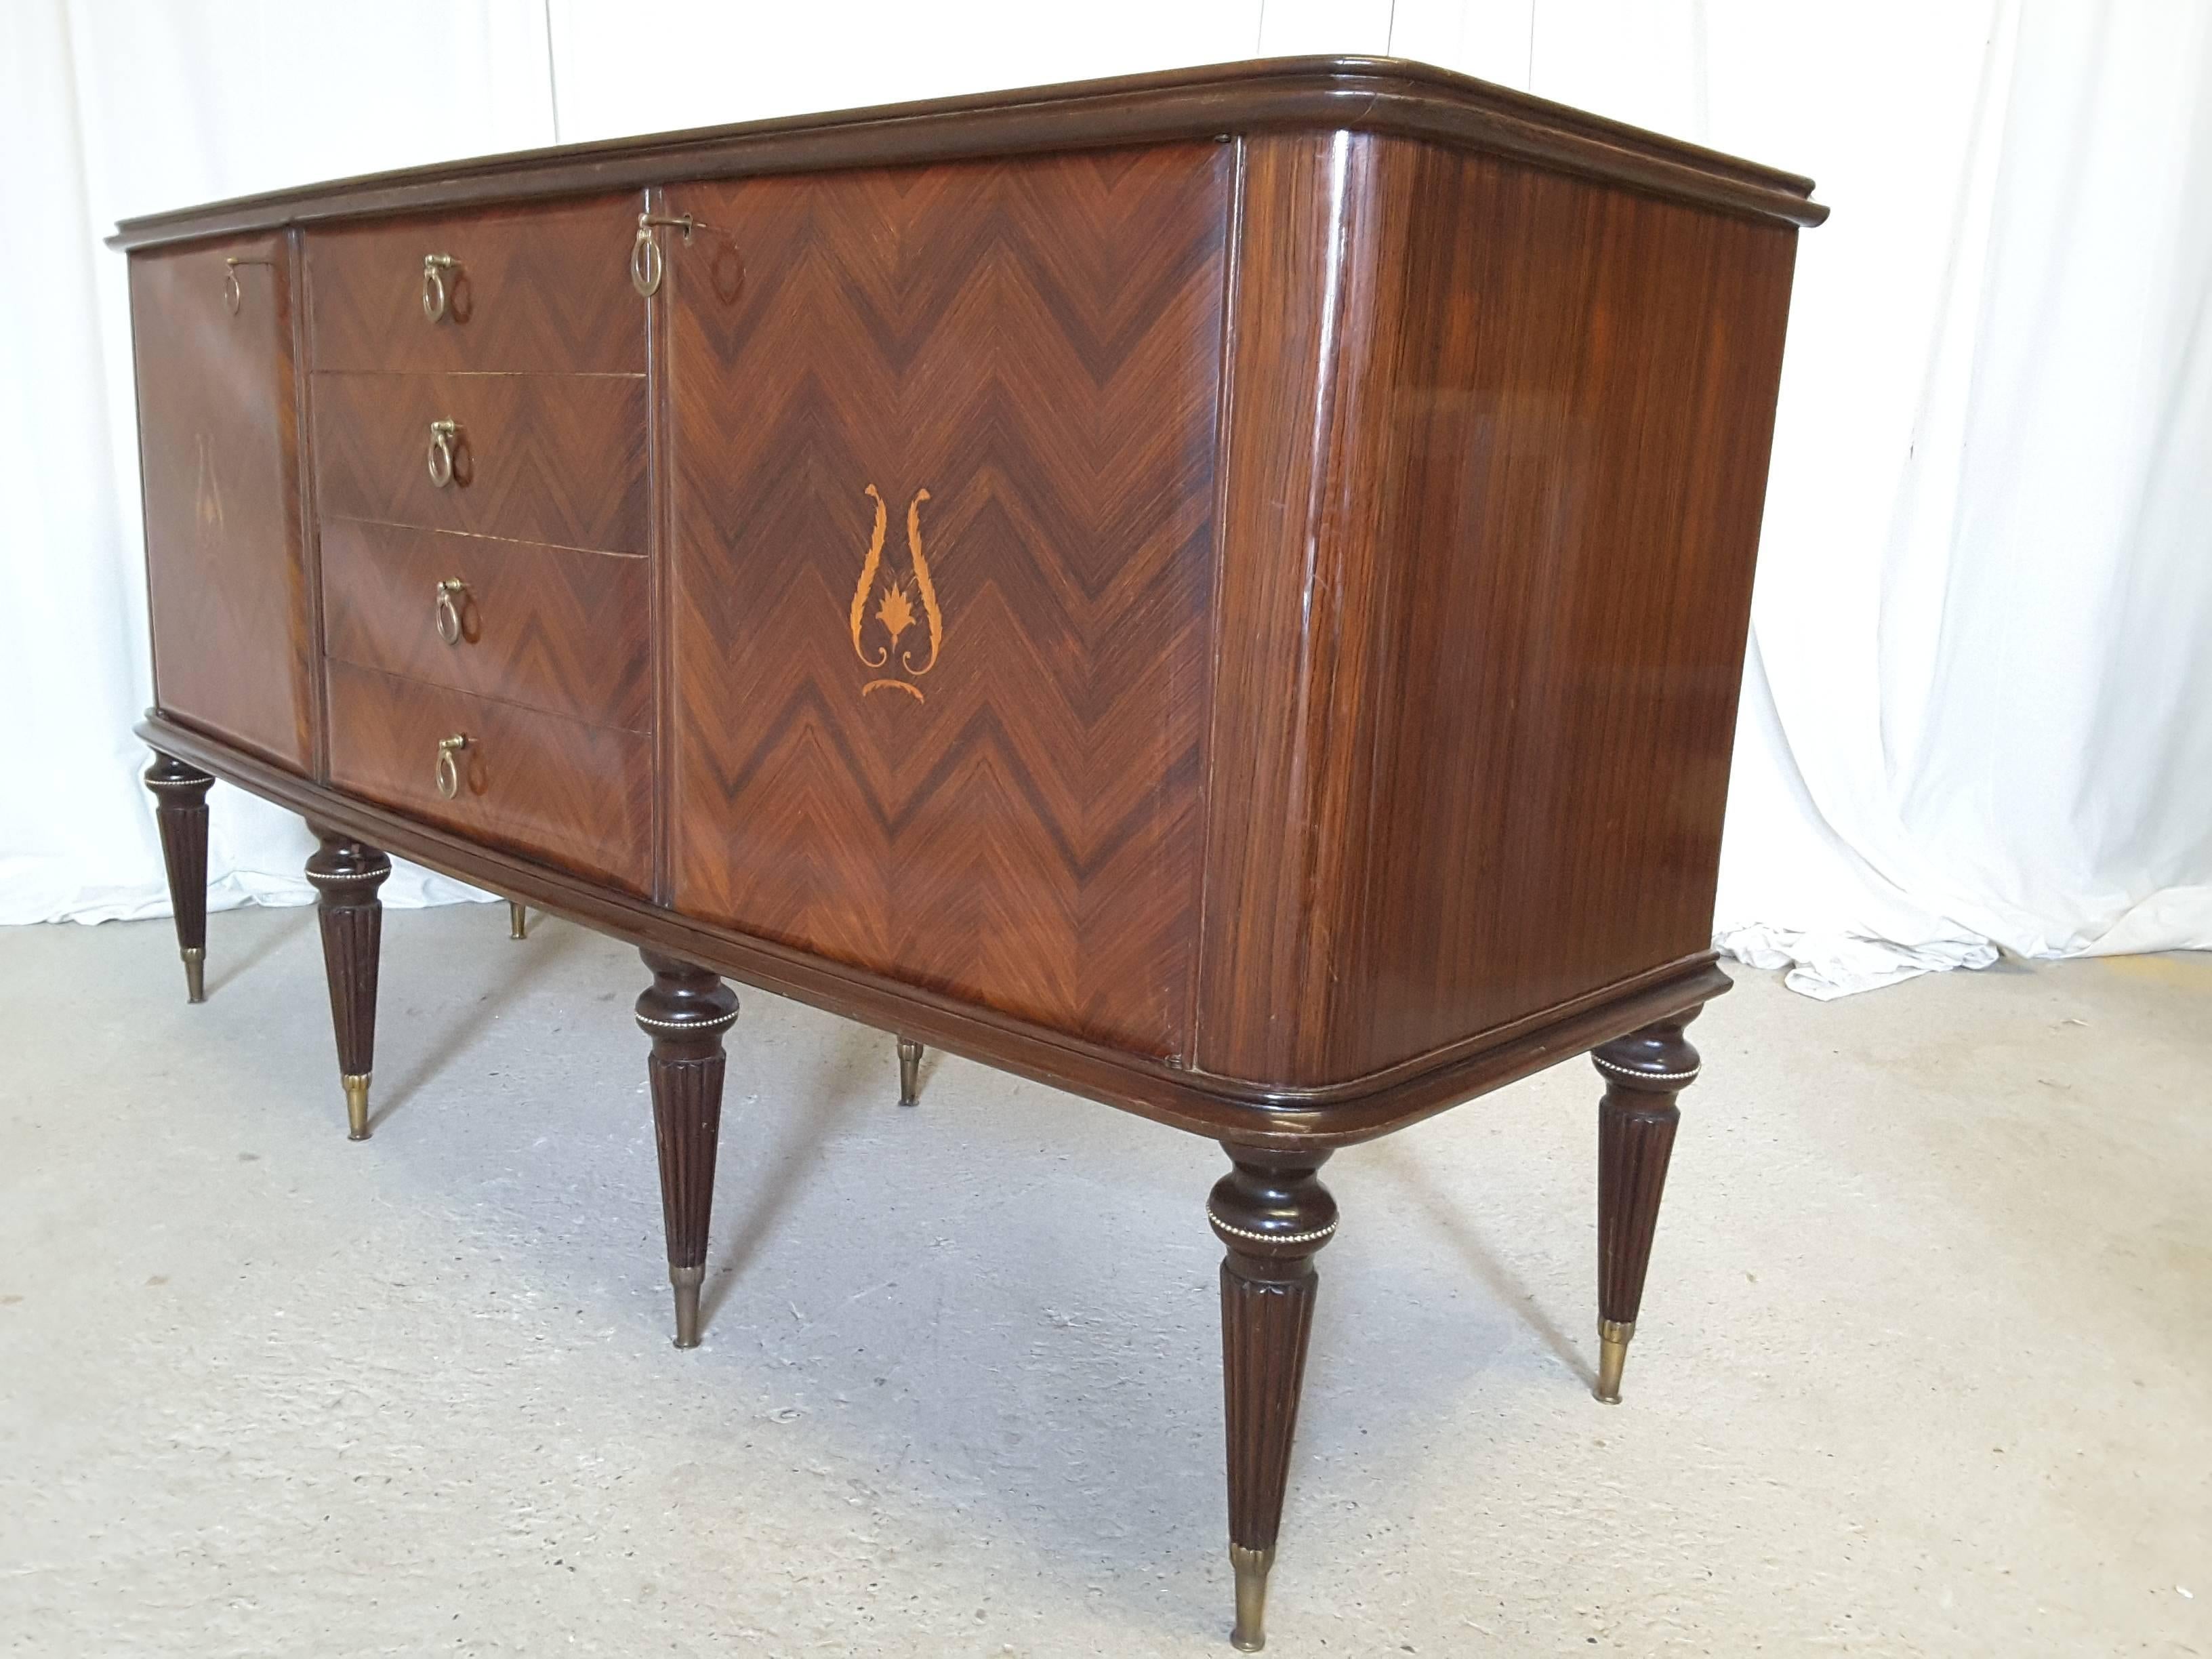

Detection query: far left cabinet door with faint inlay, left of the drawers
(131, 234), (314, 772)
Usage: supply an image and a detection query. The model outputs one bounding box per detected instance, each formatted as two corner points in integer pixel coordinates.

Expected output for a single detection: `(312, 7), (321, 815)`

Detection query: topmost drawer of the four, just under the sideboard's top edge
(308, 194), (646, 374)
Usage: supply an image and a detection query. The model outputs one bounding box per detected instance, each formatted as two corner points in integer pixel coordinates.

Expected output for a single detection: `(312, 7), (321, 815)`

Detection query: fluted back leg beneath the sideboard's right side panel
(1591, 1008), (1699, 1405)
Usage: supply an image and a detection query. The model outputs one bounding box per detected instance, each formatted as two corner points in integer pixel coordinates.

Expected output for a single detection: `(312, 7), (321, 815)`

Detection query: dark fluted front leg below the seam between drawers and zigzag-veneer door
(637, 951), (737, 1347)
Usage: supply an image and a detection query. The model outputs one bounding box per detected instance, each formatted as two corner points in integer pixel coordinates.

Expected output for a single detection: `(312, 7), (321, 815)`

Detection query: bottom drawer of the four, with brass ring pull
(327, 661), (653, 894)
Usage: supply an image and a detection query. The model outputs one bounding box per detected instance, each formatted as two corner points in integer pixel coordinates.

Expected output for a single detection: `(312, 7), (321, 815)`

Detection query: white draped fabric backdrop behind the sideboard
(0, 0), (2212, 994)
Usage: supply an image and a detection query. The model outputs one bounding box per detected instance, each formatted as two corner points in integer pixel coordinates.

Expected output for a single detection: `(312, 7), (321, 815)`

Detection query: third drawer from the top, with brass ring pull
(323, 518), (653, 732)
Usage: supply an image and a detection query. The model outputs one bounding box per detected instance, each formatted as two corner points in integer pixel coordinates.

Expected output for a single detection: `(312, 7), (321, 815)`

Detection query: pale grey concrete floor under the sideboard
(0, 907), (2212, 1659)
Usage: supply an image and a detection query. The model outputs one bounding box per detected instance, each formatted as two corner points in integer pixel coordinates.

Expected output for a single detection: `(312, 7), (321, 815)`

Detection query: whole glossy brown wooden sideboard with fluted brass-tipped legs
(115, 60), (1825, 1648)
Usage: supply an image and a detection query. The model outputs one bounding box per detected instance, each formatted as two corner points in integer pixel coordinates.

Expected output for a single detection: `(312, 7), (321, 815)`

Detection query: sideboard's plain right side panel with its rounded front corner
(1197, 137), (1796, 1084)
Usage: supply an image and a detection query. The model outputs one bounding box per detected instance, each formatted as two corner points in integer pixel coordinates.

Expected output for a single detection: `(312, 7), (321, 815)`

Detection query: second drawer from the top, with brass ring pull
(314, 374), (648, 553)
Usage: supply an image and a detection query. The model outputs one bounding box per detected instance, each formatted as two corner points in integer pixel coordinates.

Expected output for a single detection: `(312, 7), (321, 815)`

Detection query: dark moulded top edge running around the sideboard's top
(108, 58), (1827, 248)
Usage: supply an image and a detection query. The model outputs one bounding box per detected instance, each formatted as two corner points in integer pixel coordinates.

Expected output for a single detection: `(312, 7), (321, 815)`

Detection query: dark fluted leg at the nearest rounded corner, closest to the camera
(1206, 1146), (1336, 1652)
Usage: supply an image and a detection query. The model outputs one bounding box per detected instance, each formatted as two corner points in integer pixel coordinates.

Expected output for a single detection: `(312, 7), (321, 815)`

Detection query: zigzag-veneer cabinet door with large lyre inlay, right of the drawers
(661, 144), (1232, 1055)
